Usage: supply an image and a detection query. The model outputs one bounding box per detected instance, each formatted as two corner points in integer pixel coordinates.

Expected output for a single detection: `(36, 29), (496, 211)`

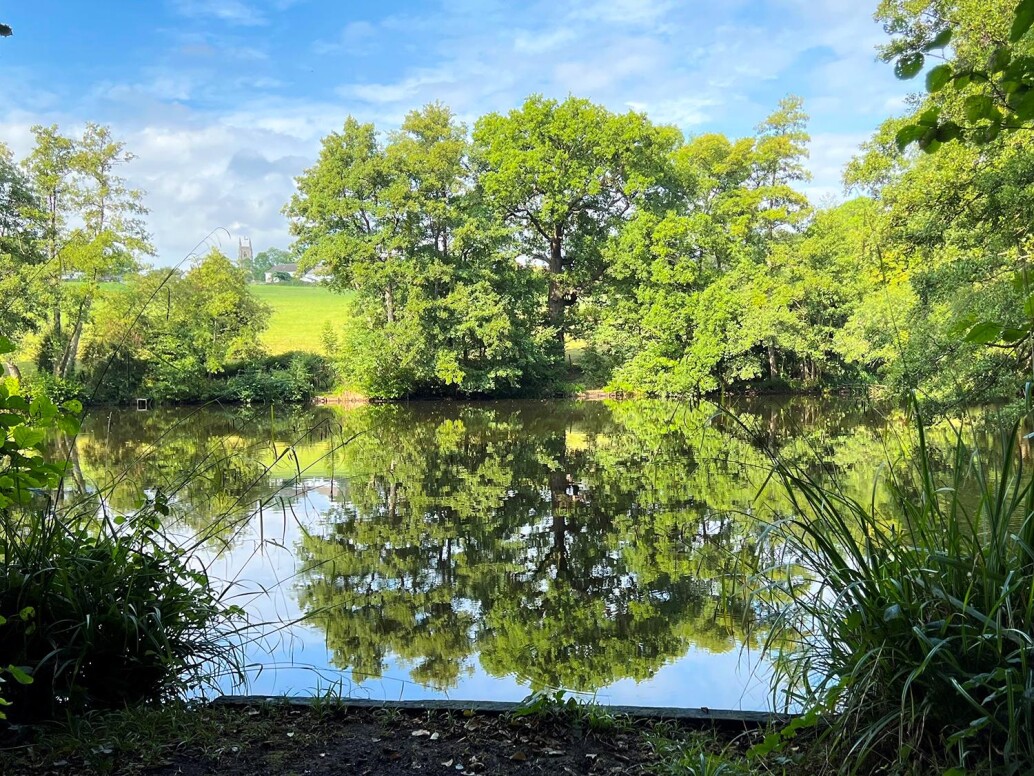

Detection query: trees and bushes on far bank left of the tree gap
(0, 123), (331, 401)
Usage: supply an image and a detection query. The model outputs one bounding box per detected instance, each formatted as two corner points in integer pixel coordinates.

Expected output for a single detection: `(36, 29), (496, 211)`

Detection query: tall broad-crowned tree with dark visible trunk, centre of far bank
(474, 95), (681, 355)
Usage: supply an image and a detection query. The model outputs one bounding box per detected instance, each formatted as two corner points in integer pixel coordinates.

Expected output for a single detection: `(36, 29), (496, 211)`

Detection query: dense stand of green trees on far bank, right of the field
(285, 72), (1034, 400)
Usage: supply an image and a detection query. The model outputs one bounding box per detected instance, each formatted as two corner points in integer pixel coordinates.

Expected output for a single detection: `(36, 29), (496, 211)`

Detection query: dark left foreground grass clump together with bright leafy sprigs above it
(0, 353), (241, 719)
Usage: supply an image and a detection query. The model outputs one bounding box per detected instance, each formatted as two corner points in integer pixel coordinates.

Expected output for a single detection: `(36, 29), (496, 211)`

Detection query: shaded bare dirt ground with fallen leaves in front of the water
(0, 706), (748, 776)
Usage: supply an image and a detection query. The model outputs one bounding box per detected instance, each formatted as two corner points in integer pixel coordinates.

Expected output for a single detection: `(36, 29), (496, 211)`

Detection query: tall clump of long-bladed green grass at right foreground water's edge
(767, 403), (1034, 773)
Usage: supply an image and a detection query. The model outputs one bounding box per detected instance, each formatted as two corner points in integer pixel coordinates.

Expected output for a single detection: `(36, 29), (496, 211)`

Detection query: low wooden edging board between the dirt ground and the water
(212, 695), (795, 727)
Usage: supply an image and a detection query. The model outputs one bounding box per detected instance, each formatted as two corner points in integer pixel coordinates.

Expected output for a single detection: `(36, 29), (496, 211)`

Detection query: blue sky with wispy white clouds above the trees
(0, 0), (908, 265)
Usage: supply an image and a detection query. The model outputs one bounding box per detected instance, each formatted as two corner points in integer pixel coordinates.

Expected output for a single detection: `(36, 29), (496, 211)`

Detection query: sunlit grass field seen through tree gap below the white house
(250, 285), (348, 355)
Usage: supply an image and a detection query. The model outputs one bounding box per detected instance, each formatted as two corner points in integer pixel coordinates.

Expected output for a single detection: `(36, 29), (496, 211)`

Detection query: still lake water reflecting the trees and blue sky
(64, 397), (976, 710)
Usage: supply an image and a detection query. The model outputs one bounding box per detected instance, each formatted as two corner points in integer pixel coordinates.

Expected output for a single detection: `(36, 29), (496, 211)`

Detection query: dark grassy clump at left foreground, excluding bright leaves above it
(0, 511), (246, 718)
